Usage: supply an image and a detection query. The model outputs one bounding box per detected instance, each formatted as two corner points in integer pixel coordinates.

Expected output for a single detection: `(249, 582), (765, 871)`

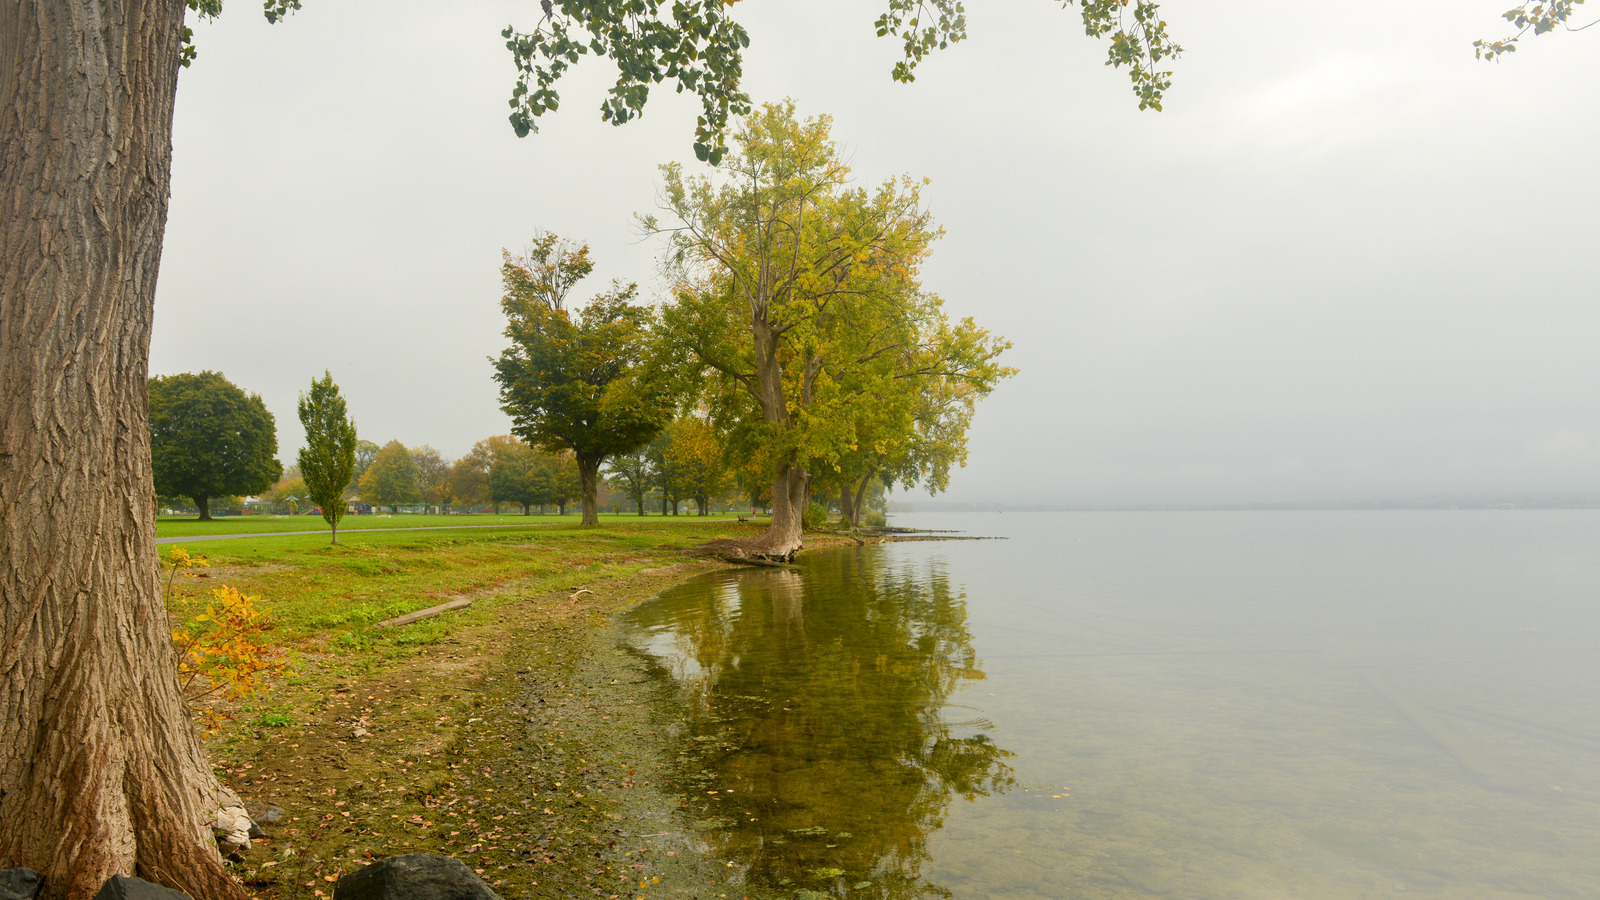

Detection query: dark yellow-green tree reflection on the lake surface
(629, 548), (1013, 898)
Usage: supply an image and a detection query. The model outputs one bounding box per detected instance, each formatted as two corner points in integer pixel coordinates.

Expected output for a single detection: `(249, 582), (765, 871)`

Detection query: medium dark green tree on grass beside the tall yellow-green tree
(494, 234), (670, 525)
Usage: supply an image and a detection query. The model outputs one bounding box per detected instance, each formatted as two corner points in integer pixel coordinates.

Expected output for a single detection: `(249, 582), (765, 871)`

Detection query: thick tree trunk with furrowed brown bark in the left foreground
(0, 0), (245, 900)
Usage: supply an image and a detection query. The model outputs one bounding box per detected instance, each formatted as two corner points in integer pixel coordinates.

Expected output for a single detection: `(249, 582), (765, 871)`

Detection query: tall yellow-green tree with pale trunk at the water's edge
(646, 104), (1010, 559)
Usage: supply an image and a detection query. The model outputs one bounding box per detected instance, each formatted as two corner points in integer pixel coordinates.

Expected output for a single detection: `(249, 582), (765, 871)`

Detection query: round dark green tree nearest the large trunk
(150, 372), (283, 522)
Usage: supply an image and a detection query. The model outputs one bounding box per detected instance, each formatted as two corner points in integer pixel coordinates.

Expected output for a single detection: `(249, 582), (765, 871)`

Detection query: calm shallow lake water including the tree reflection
(626, 511), (1600, 900)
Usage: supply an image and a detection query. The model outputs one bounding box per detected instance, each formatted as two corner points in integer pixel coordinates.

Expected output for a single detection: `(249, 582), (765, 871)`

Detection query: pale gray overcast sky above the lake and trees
(150, 0), (1600, 504)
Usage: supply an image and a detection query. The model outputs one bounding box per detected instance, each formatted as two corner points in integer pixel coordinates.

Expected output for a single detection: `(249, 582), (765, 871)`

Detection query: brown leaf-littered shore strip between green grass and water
(208, 535), (889, 900)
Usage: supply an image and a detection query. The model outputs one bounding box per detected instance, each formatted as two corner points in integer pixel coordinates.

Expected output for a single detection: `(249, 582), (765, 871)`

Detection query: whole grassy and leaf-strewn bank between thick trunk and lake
(167, 519), (870, 900)
